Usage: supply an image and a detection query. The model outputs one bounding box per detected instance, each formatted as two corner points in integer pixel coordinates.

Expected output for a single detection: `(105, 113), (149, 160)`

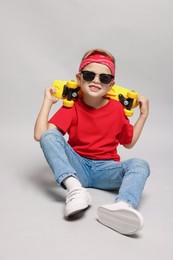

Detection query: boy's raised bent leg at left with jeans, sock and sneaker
(40, 129), (91, 217)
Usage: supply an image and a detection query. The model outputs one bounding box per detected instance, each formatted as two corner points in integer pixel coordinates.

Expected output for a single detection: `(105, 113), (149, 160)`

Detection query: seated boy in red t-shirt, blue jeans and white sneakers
(34, 49), (150, 235)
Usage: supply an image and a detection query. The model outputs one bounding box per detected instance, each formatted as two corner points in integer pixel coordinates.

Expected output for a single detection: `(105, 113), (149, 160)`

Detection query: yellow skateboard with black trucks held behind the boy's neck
(52, 80), (138, 117)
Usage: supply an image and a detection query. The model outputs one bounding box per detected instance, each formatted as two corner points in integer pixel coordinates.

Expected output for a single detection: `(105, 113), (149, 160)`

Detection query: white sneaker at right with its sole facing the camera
(98, 201), (144, 235)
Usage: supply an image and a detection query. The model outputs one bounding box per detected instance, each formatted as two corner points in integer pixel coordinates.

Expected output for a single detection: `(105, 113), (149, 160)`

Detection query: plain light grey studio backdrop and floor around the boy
(0, 0), (173, 260)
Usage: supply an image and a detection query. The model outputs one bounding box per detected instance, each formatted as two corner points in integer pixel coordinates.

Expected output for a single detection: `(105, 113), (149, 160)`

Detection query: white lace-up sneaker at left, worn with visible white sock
(65, 188), (92, 217)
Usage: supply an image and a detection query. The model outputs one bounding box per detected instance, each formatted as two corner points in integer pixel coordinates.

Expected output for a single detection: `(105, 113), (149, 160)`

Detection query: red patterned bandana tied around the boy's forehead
(79, 54), (115, 76)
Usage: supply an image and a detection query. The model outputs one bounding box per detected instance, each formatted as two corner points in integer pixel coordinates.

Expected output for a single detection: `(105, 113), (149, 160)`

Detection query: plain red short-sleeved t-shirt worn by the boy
(49, 99), (133, 161)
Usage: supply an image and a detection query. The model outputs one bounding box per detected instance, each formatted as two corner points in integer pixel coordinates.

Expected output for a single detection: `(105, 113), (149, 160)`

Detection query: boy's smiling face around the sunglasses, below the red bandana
(76, 63), (115, 97)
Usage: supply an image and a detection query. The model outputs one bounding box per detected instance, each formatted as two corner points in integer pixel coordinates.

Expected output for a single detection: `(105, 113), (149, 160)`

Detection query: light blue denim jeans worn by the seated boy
(40, 129), (150, 208)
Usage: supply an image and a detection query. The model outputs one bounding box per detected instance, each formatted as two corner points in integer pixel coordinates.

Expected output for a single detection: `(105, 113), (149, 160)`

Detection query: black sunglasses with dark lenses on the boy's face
(81, 70), (114, 84)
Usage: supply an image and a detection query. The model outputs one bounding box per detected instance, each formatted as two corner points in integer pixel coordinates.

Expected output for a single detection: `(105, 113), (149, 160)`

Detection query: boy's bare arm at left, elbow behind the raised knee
(34, 87), (58, 141)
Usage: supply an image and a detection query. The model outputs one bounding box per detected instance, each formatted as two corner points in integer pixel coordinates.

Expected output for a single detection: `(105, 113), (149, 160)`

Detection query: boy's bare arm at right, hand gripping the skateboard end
(124, 96), (149, 149)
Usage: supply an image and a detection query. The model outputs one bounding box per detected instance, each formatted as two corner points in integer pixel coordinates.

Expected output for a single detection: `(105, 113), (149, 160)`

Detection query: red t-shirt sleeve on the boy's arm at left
(48, 106), (74, 135)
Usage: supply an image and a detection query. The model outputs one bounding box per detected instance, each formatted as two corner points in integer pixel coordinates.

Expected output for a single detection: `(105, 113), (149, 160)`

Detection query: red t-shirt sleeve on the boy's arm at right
(118, 117), (133, 145)
